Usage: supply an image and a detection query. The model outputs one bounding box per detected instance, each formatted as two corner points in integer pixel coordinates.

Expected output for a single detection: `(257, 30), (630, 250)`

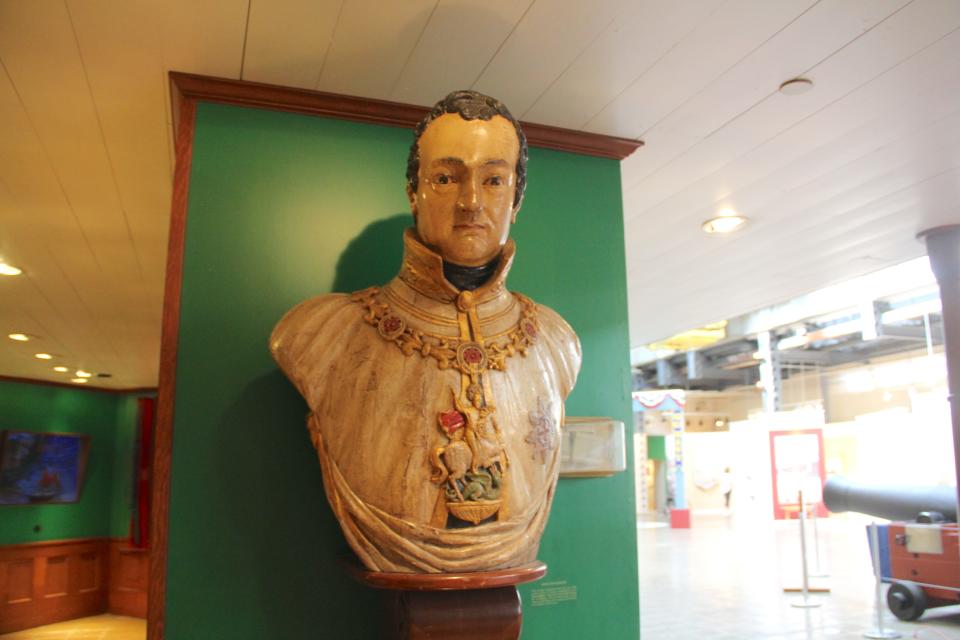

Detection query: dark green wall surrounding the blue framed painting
(0, 380), (137, 544)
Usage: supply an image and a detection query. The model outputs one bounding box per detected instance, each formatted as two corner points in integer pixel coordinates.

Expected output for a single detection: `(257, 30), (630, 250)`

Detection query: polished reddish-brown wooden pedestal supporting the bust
(348, 561), (547, 640)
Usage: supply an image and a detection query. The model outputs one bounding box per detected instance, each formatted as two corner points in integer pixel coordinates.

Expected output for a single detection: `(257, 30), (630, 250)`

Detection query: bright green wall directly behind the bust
(166, 105), (639, 640)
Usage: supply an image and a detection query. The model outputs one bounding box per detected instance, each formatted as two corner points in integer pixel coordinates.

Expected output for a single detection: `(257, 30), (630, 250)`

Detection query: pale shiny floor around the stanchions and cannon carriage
(637, 515), (960, 640)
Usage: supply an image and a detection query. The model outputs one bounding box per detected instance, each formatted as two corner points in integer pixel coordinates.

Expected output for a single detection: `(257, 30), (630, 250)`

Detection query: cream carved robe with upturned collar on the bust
(270, 230), (581, 572)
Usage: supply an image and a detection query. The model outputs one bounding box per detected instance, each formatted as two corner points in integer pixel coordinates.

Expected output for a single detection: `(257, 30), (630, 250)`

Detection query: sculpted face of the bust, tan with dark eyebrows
(407, 113), (520, 267)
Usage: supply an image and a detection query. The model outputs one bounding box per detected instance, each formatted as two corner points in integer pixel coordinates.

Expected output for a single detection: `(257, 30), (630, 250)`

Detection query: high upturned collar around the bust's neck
(399, 228), (516, 304)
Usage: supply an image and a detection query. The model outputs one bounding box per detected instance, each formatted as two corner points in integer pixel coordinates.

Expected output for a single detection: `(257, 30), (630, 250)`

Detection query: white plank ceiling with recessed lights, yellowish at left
(0, 0), (960, 388)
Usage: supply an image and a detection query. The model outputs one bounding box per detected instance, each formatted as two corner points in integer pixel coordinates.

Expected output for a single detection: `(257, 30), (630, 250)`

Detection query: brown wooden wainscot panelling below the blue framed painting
(0, 538), (108, 633)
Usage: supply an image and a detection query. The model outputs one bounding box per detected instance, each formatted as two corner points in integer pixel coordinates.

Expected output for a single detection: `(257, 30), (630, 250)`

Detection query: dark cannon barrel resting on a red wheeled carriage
(823, 478), (957, 522)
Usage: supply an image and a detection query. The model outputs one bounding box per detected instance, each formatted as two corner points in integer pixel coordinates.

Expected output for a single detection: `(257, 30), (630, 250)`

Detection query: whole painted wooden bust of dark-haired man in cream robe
(270, 91), (581, 573)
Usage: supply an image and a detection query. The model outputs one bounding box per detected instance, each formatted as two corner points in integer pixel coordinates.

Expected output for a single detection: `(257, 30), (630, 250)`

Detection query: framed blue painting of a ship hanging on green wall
(0, 429), (90, 505)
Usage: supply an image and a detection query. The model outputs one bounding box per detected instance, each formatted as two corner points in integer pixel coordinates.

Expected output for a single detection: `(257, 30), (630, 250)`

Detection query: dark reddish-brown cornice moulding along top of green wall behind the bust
(170, 71), (643, 160)
